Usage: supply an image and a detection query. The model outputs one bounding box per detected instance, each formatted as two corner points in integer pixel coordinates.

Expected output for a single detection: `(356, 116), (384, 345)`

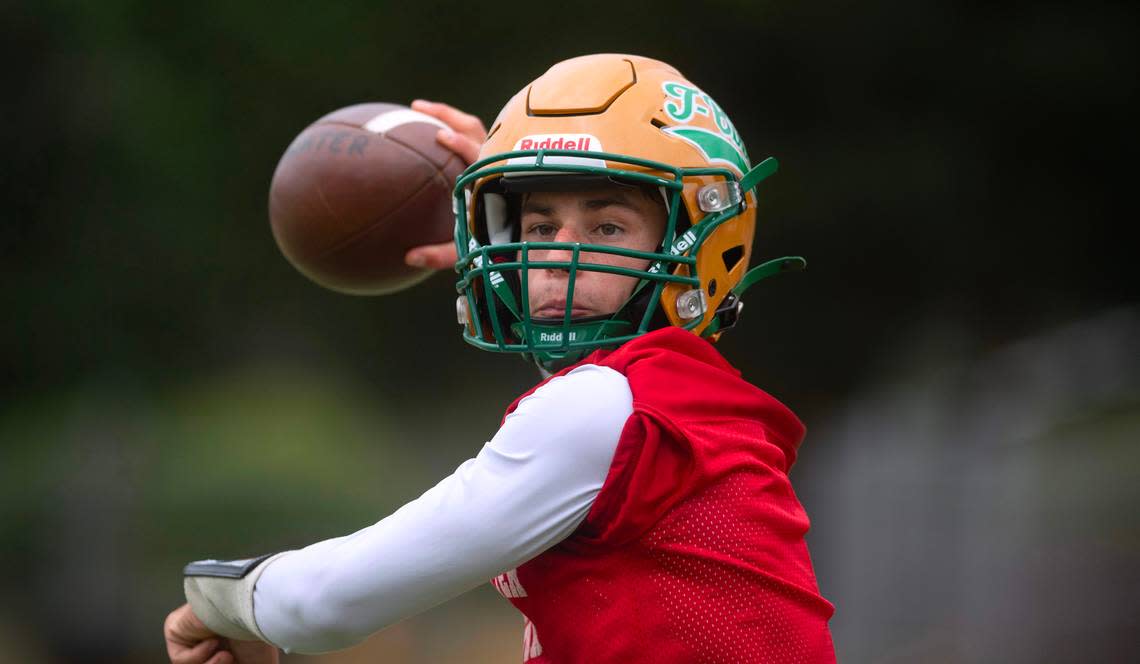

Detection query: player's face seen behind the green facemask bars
(522, 185), (667, 319)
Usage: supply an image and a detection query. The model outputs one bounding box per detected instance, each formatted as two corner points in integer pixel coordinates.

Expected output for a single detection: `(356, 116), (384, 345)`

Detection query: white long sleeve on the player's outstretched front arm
(253, 365), (633, 653)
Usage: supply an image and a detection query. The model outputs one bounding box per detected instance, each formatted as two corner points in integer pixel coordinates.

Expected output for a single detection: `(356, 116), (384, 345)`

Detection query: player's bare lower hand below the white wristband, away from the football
(162, 604), (277, 664)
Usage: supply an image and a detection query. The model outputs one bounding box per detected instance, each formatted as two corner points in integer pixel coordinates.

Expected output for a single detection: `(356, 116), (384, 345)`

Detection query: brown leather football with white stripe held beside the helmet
(269, 104), (464, 295)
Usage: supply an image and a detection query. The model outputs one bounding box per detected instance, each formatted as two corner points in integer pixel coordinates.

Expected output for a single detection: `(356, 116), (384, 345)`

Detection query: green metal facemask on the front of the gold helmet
(454, 149), (788, 372)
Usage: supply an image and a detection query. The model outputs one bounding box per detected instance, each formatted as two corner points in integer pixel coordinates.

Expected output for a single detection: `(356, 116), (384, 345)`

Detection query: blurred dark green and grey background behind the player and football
(0, 0), (1140, 663)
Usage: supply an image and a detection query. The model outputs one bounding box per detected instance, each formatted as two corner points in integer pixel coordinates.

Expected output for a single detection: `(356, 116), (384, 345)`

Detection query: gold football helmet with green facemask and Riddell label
(454, 54), (804, 371)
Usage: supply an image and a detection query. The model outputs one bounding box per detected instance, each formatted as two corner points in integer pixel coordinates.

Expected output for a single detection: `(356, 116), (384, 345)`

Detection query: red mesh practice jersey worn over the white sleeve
(494, 327), (836, 664)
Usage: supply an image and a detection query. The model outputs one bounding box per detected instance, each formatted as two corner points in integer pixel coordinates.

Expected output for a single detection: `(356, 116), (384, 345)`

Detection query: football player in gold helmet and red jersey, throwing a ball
(165, 55), (834, 664)
